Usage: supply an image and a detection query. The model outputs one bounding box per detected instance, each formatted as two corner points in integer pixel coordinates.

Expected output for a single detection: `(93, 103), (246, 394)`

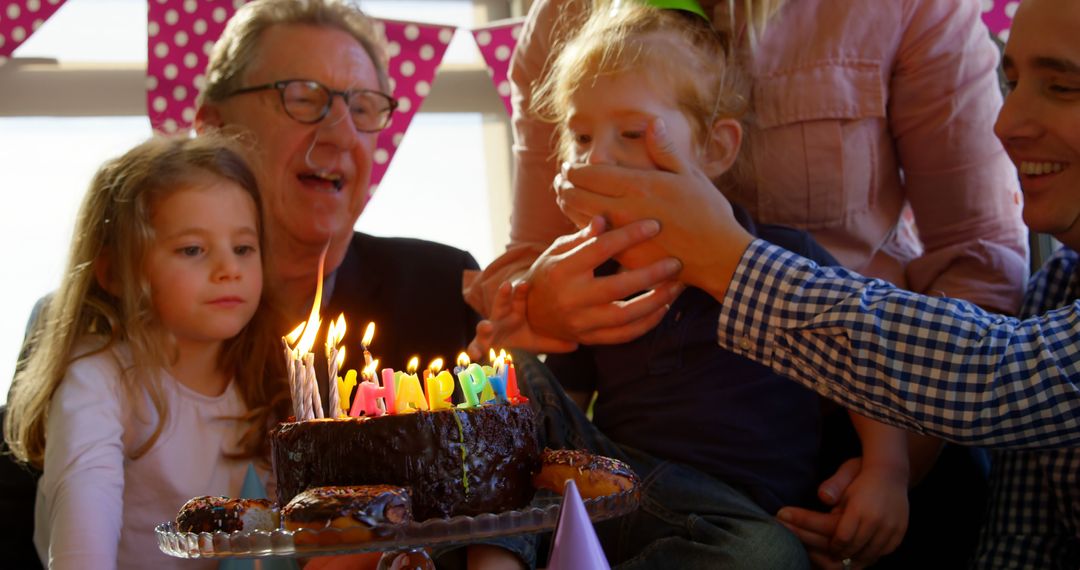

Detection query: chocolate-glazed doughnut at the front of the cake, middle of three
(281, 485), (413, 546)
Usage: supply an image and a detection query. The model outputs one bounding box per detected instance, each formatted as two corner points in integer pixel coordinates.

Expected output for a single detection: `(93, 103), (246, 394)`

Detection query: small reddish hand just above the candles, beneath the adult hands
(467, 282), (578, 362)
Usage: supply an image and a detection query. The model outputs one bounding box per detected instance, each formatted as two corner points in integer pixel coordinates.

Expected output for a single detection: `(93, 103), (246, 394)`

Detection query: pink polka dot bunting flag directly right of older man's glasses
(372, 19), (456, 188)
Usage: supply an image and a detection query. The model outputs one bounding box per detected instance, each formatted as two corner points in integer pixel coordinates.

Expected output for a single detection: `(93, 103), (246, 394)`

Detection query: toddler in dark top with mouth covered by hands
(477, 2), (909, 568)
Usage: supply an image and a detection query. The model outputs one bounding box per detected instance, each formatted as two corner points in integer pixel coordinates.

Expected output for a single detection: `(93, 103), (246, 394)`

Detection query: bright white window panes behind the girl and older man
(0, 0), (505, 403)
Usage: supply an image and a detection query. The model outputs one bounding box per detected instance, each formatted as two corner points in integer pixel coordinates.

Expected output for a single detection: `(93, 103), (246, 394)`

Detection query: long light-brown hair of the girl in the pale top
(4, 135), (288, 467)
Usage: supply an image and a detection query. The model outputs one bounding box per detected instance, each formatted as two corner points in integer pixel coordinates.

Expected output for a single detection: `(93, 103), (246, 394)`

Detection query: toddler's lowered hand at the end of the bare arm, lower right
(822, 461), (908, 566)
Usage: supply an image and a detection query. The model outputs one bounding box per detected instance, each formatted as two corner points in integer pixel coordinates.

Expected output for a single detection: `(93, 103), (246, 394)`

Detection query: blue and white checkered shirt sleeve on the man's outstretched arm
(718, 240), (1080, 449)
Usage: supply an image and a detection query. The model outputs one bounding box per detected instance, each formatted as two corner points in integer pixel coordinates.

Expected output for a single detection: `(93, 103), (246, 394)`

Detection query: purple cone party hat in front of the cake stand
(548, 479), (611, 570)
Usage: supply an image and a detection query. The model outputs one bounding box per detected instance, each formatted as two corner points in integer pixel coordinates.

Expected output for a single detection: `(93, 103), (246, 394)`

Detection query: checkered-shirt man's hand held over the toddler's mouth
(557, 119), (753, 298)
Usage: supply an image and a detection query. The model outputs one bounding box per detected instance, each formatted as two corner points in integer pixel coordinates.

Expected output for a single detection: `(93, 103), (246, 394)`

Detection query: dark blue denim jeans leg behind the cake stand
(513, 351), (809, 570)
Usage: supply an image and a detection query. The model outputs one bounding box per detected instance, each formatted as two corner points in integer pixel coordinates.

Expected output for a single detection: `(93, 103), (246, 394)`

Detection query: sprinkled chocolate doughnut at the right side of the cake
(532, 449), (637, 499)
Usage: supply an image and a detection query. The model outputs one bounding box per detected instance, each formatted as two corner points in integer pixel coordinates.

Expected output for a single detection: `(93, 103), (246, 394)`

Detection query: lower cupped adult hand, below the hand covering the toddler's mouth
(522, 218), (683, 344)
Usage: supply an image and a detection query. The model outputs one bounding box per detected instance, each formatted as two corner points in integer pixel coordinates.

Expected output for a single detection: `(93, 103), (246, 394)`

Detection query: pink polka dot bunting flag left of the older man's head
(146, 0), (238, 133)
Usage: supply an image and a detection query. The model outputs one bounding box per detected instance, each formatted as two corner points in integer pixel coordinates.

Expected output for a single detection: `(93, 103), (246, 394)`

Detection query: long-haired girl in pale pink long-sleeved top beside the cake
(5, 136), (287, 569)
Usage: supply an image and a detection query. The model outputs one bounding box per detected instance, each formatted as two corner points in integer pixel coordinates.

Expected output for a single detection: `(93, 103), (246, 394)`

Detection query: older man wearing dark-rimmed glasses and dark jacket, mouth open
(195, 0), (476, 386)
